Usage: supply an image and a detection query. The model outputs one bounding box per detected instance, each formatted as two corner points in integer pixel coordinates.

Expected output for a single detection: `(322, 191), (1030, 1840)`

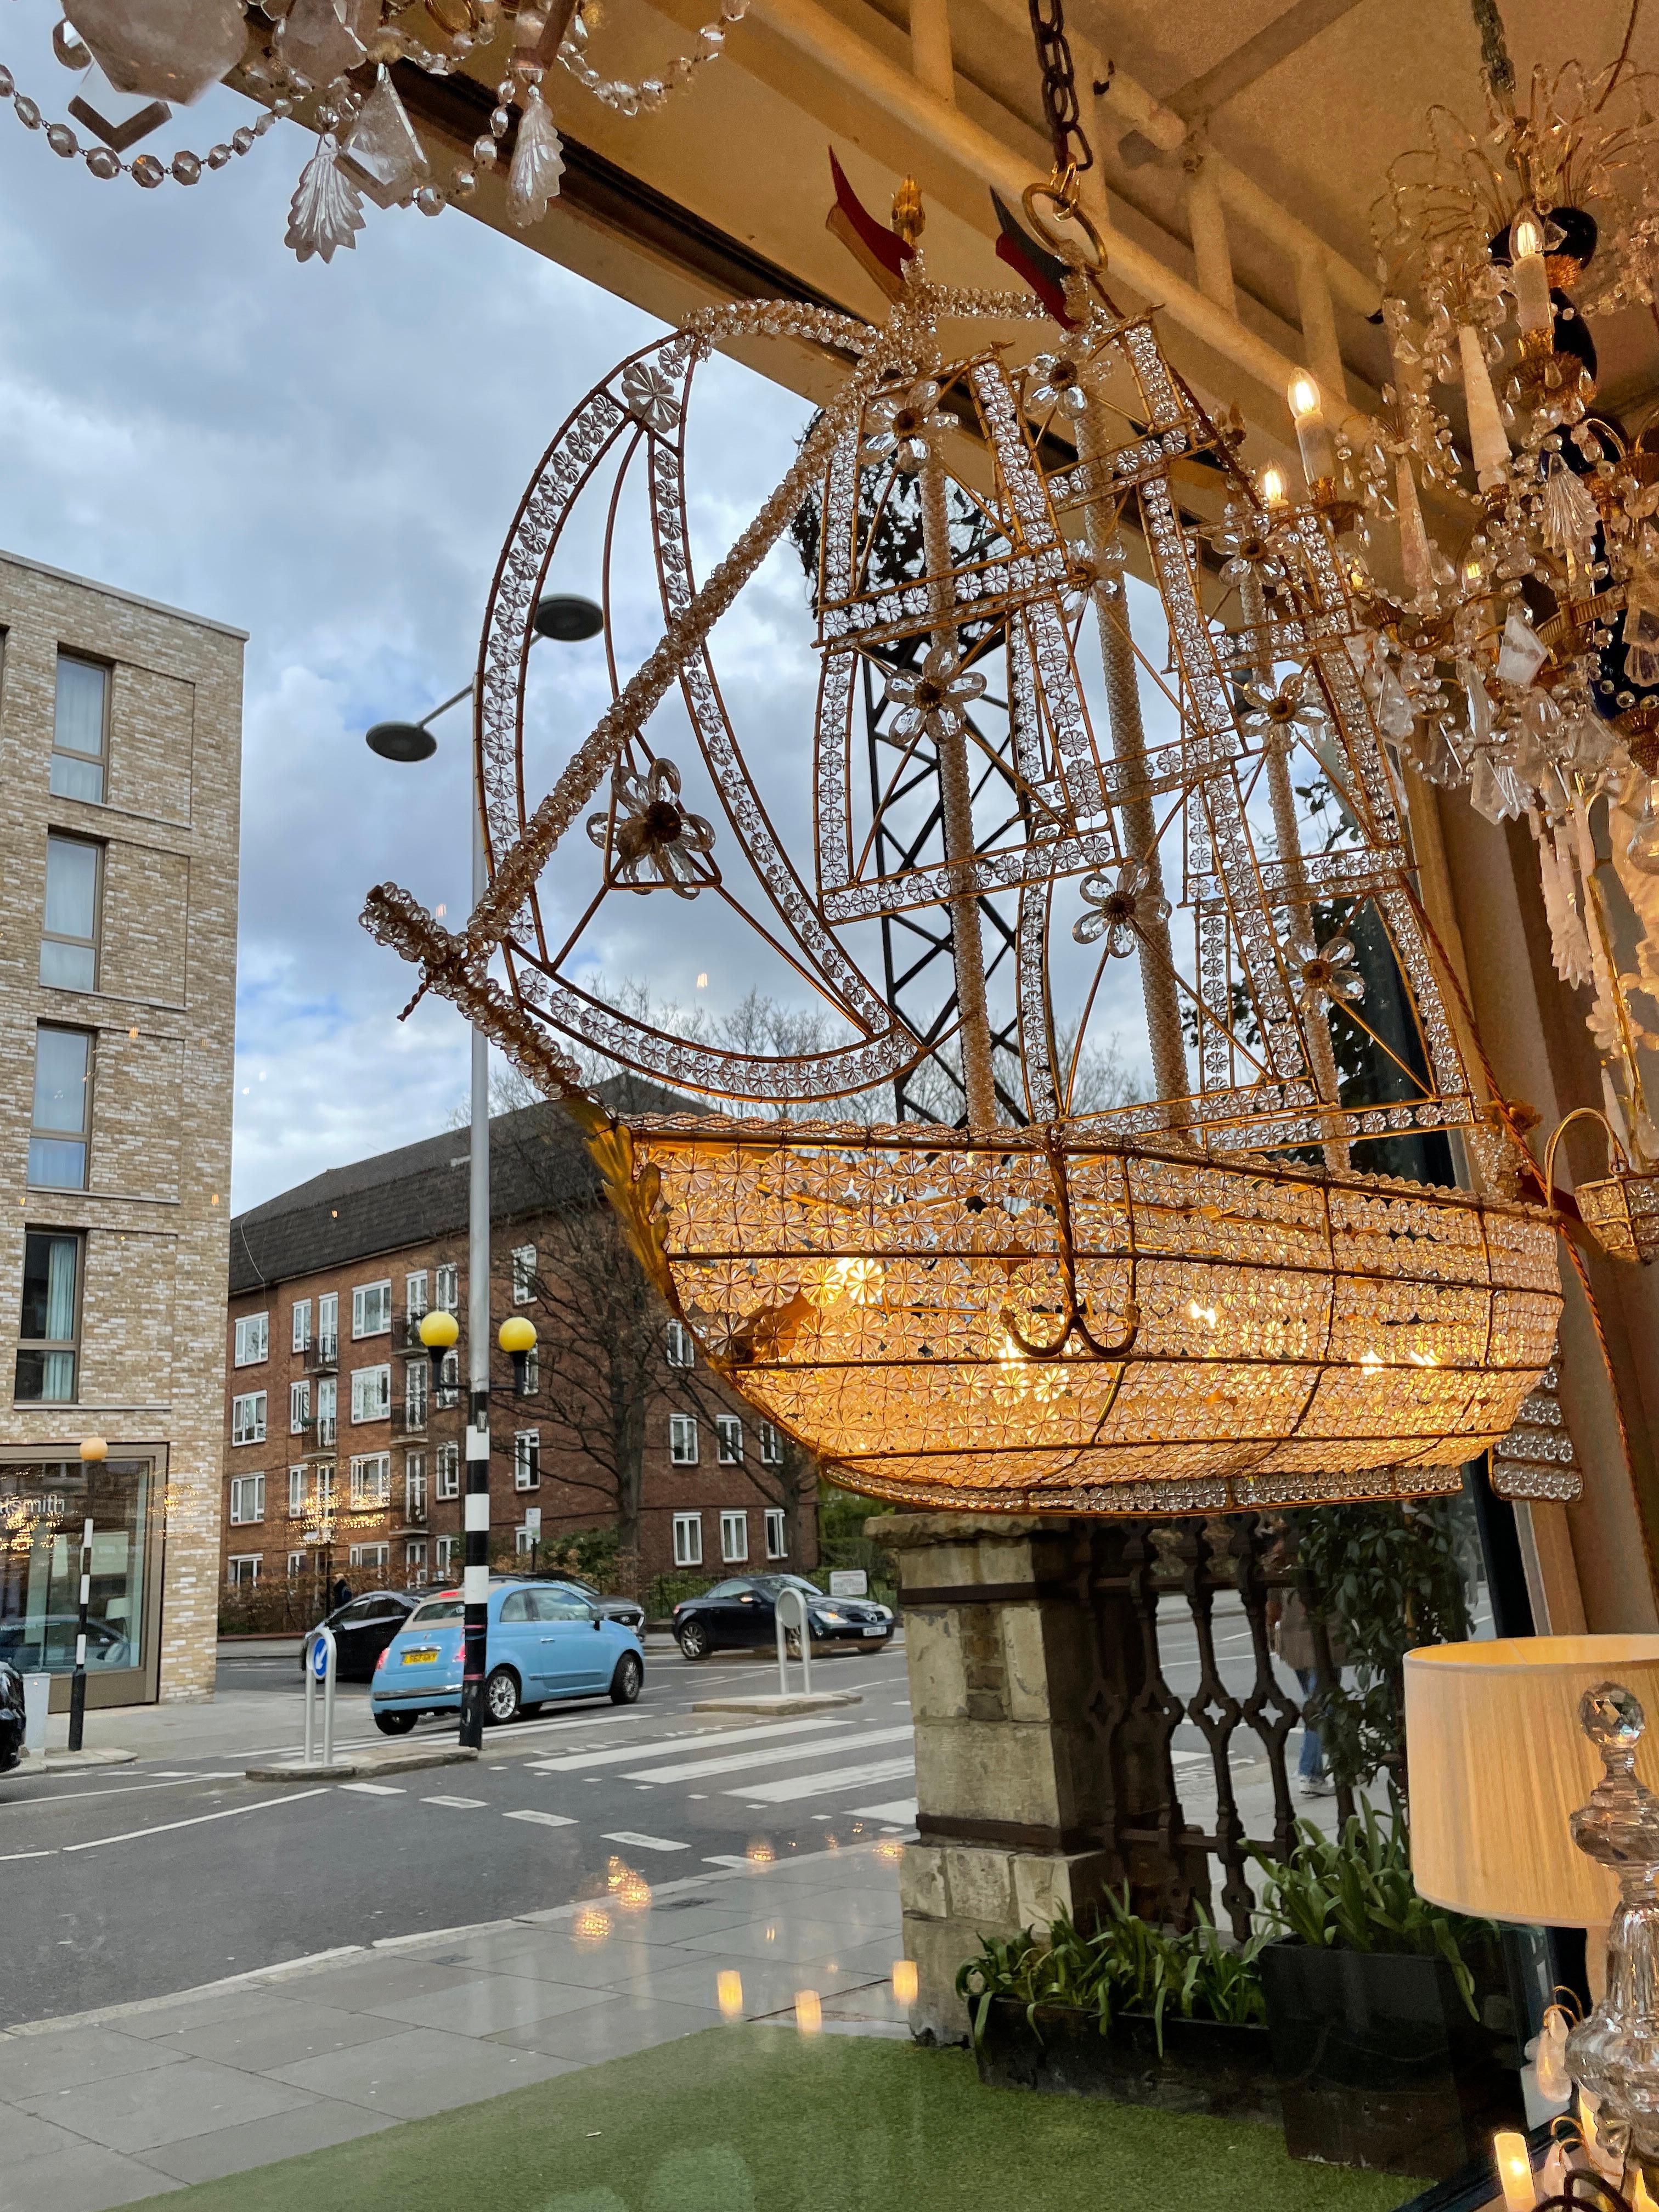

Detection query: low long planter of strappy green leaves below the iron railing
(956, 1891), (1278, 2121)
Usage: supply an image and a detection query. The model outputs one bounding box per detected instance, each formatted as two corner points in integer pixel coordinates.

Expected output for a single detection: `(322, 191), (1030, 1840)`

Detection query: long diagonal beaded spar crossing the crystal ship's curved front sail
(467, 321), (909, 956)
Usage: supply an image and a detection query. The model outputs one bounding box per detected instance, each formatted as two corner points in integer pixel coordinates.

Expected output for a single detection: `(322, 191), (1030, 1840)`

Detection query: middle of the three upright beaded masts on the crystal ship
(1077, 376), (1192, 1119)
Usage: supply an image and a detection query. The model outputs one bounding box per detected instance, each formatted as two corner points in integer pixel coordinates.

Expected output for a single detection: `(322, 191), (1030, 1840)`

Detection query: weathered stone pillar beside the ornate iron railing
(867, 1513), (1207, 2042)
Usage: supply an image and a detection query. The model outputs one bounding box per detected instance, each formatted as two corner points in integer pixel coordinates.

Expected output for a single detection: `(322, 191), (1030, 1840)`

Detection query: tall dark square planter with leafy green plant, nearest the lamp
(1256, 1805), (1526, 2181)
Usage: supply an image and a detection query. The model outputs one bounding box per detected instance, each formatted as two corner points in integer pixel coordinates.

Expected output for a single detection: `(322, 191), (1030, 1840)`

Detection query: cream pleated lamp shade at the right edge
(1404, 1637), (1659, 1929)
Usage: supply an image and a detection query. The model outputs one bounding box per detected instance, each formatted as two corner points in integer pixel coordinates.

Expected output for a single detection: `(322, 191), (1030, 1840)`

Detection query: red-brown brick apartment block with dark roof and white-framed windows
(223, 1099), (819, 1595)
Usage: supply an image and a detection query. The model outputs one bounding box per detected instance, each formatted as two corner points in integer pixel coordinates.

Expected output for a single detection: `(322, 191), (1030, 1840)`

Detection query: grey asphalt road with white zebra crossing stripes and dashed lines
(0, 1608), (1345, 2024)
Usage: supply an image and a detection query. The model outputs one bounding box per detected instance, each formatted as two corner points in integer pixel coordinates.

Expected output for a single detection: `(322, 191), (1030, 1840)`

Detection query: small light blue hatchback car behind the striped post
(369, 1582), (646, 1736)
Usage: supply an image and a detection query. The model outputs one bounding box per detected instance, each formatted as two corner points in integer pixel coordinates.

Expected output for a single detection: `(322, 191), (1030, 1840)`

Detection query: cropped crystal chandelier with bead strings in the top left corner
(0, 0), (748, 261)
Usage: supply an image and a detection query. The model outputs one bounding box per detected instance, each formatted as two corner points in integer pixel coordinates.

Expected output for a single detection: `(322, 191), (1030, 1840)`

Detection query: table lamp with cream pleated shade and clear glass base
(1404, 1637), (1659, 2161)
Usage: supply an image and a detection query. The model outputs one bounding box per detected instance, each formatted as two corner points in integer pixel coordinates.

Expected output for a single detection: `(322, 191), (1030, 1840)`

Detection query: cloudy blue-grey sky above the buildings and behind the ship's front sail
(0, 30), (1186, 1210)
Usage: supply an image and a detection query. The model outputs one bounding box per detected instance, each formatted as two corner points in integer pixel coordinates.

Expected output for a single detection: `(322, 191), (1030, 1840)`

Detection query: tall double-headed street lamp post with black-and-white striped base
(367, 593), (604, 1750)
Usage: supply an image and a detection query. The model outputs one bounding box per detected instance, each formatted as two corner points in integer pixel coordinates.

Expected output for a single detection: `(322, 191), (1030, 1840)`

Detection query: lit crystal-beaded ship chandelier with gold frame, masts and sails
(365, 160), (1577, 1513)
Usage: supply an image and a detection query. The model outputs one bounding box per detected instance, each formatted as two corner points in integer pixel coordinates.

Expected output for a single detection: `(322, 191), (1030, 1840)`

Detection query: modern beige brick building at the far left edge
(0, 553), (244, 1703)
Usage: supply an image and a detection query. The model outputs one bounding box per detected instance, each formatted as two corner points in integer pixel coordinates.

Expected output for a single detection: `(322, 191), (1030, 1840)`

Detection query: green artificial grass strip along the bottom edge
(146, 2026), (1423, 2212)
